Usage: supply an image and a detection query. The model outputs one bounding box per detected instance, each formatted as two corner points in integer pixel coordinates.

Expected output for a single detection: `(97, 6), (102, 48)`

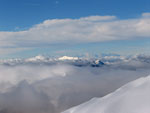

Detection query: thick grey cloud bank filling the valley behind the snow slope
(0, 56), (150, 113)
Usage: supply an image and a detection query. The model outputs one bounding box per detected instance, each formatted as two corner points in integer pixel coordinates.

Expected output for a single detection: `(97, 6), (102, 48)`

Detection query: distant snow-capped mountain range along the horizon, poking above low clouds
(0, 55), (150, 70)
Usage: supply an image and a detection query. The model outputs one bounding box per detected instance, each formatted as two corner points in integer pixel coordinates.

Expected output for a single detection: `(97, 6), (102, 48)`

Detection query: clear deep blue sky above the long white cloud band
(0, 0), (150, 30)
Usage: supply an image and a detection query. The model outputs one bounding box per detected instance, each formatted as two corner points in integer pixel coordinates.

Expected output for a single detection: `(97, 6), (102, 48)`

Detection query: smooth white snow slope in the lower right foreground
(63, 76), (150, 113)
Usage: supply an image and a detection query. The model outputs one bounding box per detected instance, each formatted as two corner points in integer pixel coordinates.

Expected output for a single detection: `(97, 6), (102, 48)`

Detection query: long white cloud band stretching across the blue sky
(0, 13), (150, 55)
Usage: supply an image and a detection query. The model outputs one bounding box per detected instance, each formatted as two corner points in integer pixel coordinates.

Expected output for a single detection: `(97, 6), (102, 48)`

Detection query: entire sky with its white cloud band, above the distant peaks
(0, 0), (150, 58)
